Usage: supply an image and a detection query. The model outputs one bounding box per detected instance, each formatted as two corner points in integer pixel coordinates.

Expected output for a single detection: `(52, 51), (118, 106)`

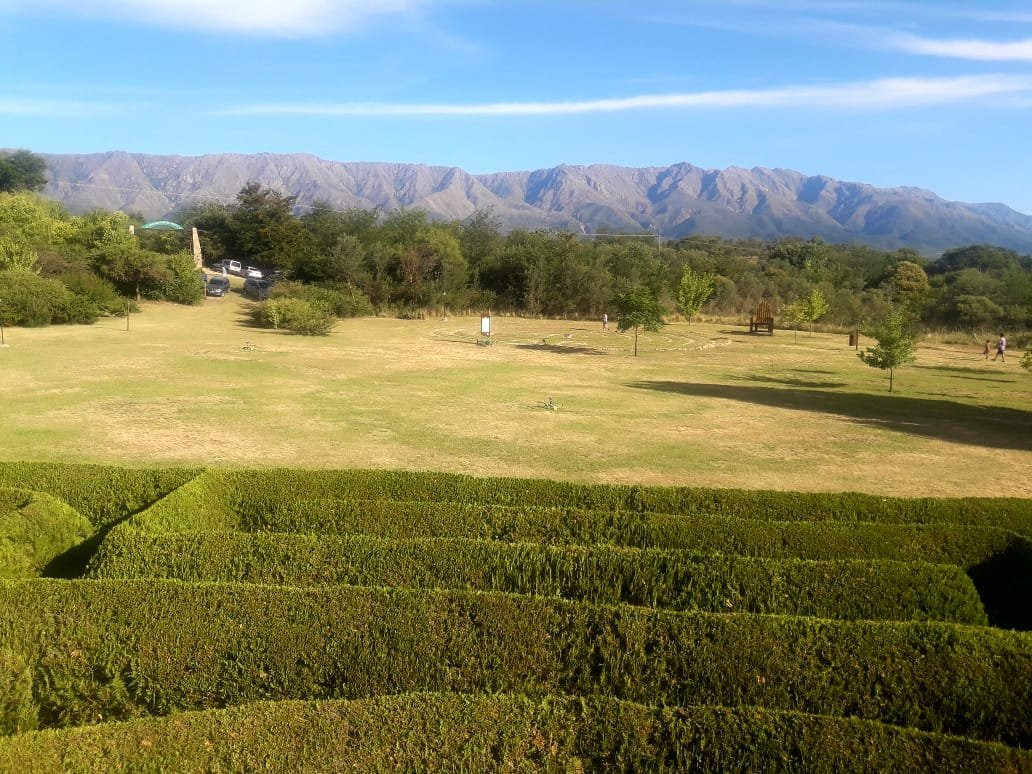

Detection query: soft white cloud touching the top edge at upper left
(0, 0), (431, 37)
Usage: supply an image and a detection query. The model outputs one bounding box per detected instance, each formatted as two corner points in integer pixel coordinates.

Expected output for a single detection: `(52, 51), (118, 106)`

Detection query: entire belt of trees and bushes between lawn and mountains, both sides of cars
(0, 151), (1032, 334)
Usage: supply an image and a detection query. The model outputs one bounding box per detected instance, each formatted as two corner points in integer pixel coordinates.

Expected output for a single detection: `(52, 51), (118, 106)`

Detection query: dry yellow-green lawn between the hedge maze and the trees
(0, 293), (1032, 496)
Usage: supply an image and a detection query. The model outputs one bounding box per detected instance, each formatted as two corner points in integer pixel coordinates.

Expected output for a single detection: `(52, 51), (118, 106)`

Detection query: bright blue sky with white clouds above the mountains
(0, 0), (1032, 214)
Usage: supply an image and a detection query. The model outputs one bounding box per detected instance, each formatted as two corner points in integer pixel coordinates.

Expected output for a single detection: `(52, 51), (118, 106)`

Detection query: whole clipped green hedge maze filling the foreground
(0, 463), (1032, 772)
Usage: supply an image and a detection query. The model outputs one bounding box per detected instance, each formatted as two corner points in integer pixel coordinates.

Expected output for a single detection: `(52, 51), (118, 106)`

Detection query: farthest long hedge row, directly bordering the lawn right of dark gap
(131, 469), (1032, 547)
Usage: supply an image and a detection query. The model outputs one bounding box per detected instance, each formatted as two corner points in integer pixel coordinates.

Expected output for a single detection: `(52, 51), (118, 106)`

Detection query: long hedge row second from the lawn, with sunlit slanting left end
(132, 485), (1032, 568)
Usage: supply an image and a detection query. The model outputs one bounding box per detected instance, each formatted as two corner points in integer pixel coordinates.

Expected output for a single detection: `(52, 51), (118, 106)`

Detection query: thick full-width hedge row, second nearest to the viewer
(0, 579), (1032, 746)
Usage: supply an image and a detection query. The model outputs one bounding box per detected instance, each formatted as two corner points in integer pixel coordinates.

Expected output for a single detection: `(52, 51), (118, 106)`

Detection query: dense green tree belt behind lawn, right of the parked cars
(181, 183), (1032, 329)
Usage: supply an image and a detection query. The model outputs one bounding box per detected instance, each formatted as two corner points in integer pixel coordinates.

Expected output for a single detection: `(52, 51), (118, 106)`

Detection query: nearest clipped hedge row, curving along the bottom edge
(0, 694), (1032, 774)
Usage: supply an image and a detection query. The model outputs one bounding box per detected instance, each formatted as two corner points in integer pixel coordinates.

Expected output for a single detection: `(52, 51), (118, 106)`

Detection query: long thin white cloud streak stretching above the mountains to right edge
(218, 75), (1032, 117)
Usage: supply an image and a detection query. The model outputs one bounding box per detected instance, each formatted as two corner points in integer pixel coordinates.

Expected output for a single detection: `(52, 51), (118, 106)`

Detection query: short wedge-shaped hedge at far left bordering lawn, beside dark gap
(0, 462), (200, 527)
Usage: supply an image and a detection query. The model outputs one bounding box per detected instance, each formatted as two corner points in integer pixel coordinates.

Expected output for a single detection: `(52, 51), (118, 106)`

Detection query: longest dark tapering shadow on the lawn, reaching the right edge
(627, 381), (1032, 451)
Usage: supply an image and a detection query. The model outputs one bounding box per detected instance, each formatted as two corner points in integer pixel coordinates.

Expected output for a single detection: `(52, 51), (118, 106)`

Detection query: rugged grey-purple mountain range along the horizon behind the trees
(41, 152), (1032, 254)
